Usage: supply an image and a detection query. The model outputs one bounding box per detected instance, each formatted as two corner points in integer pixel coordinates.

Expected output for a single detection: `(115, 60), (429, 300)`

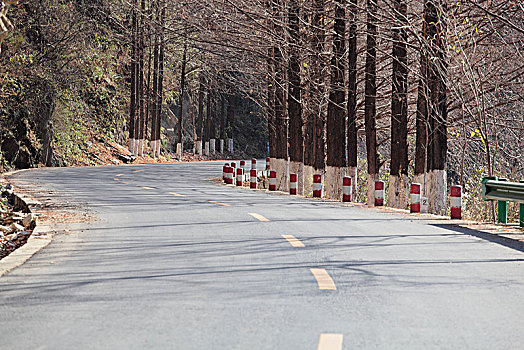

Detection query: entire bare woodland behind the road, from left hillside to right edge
(0, 0), (524, 219)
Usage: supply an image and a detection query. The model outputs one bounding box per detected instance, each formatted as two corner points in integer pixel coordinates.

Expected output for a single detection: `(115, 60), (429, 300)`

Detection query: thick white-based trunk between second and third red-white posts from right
(388, 0), (408, 209)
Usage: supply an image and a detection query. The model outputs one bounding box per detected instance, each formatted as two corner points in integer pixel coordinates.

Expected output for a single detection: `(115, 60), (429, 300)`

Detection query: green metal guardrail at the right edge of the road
(482, 177), (524, 227)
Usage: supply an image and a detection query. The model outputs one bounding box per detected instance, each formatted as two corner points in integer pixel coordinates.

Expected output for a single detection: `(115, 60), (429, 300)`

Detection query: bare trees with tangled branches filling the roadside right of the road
(187, 0), (524, 216)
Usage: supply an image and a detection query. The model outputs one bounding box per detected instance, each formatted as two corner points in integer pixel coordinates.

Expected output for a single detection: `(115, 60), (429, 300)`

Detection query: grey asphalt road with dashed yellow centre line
(0, 163), (524, 350)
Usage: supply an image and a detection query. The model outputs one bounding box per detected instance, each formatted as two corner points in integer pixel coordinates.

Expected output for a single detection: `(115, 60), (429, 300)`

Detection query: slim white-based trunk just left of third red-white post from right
(365, 0), (379, 205)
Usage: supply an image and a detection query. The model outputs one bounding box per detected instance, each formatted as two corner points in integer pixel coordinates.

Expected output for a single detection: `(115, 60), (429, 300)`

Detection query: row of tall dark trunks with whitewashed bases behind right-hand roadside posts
(256, 0), (456, 212)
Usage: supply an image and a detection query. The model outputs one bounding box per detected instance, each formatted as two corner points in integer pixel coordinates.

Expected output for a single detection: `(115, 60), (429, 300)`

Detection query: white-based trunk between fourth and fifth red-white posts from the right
(326, 0), (346, 199)
